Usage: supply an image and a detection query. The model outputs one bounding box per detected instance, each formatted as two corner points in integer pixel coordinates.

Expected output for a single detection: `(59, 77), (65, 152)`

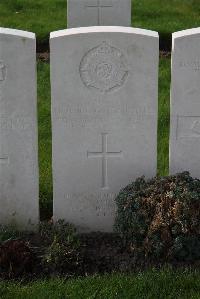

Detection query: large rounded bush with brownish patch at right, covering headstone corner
(115, 172), (200, 262)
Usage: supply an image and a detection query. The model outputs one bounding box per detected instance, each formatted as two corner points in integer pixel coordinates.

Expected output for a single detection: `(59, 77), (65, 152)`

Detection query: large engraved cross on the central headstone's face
(87, 133), (123, 189)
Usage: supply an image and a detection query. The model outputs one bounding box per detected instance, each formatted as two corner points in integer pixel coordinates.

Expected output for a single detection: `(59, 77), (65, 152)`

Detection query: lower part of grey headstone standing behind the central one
(67, 0), (131, 28)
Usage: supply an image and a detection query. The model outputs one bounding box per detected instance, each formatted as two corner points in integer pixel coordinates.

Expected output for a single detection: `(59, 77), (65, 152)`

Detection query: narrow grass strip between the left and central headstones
(38, 62), (53, 219)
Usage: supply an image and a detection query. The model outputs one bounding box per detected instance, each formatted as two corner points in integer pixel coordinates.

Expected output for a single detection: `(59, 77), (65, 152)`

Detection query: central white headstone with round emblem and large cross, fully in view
(50, 27), (159, 232)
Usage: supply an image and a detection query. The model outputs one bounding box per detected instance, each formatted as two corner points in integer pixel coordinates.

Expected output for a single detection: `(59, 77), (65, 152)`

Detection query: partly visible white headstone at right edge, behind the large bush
(170, 28), (200, 178)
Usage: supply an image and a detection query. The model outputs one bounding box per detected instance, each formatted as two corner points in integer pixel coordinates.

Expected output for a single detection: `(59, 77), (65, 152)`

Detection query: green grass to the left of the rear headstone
(0, 0), (67, 43)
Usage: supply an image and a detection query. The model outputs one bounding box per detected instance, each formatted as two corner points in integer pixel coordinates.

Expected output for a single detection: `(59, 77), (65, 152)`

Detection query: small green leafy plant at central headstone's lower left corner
(40, 220), (82, 274)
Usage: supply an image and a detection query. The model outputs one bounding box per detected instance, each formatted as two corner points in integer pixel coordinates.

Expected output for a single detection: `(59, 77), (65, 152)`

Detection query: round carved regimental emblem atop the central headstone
(80, 42), (128, 92)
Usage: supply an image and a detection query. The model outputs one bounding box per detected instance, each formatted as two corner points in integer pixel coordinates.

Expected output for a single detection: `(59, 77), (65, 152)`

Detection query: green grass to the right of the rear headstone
(132, 0), (200, 49)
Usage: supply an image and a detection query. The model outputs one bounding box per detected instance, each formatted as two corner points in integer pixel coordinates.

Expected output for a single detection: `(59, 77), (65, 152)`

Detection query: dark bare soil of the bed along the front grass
(0, 233), (200, 281)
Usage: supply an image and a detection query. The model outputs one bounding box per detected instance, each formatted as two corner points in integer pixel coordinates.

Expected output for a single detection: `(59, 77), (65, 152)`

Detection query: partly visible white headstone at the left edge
(0, 28), (39, 230)
